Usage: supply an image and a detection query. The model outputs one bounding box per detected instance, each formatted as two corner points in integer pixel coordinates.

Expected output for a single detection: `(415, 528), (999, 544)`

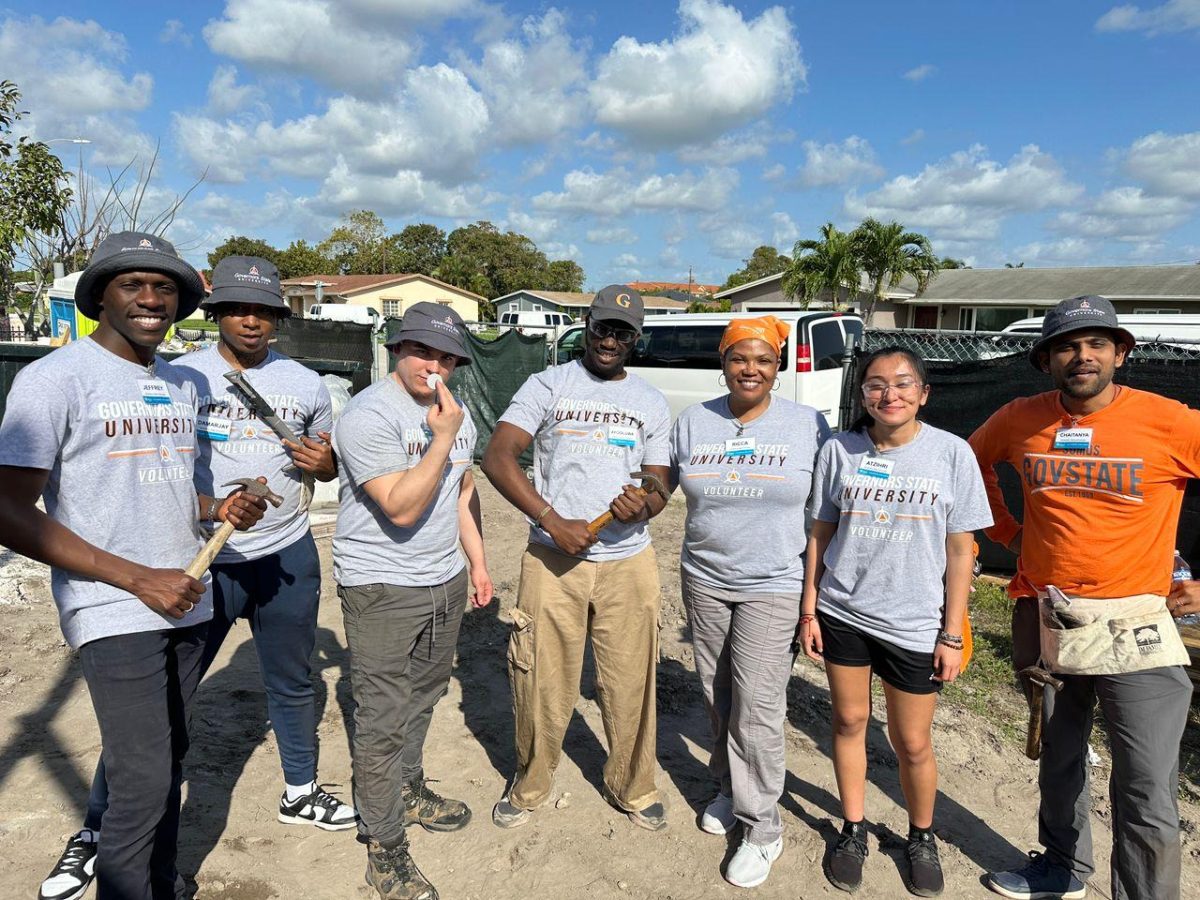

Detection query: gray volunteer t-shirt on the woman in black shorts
(812, 425), (991, 653)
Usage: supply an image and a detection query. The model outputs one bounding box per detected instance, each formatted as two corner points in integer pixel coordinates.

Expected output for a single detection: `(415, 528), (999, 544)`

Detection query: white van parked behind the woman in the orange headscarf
(556, 311), (863, 430)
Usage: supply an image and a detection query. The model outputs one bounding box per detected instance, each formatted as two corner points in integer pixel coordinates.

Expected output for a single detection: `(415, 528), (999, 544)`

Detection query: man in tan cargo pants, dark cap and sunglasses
(484, 284), (670, 830)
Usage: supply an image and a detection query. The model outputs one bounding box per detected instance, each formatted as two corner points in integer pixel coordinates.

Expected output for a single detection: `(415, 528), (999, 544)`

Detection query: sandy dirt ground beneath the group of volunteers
(0, 478), (1200, 900)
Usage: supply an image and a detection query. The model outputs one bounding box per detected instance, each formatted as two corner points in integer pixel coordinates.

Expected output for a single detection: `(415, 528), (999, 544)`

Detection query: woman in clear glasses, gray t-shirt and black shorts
(799, 347), (991, 896)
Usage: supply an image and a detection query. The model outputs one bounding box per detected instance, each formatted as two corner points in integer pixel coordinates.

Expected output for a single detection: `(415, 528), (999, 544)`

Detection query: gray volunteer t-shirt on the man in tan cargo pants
(500, 361), (671, 560)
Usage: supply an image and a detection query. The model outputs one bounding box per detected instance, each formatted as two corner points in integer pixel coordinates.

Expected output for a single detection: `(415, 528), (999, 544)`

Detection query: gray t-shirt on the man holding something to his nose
(334, 376), (475, 587)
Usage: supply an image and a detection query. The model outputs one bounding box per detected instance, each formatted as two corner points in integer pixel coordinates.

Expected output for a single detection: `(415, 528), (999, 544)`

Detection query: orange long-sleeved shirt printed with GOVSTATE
(970, 386), (1200, 598)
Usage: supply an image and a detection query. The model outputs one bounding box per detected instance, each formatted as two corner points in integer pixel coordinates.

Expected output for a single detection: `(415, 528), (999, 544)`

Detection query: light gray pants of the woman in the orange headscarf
(680, 572), (800, 845)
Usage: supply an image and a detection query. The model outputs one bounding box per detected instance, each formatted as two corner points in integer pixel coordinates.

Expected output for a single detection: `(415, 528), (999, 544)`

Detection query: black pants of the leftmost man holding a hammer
(79, 623), (208, 900)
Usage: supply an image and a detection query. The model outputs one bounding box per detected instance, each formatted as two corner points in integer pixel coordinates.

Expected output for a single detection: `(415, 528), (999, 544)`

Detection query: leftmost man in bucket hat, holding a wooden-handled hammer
(0, 232), (265, 900)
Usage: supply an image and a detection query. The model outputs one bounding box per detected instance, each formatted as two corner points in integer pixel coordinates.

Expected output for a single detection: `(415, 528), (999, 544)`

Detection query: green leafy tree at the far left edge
(0, 80), (71, 303)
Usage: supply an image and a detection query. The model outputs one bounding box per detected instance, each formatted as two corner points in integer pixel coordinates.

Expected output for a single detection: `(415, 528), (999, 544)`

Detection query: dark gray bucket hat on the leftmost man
(76, 232), (204, 322)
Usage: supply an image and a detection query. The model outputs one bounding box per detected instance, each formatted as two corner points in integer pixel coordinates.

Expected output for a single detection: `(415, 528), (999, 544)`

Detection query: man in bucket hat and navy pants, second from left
(47, 257), (355, 896)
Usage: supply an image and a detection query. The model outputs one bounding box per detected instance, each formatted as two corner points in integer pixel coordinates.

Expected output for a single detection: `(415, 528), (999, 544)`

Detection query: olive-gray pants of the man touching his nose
(337, 569), (467, 850)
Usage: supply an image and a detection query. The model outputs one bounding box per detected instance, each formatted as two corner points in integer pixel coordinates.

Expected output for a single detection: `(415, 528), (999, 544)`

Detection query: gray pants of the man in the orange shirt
(1013, 598), (1192, 900)
